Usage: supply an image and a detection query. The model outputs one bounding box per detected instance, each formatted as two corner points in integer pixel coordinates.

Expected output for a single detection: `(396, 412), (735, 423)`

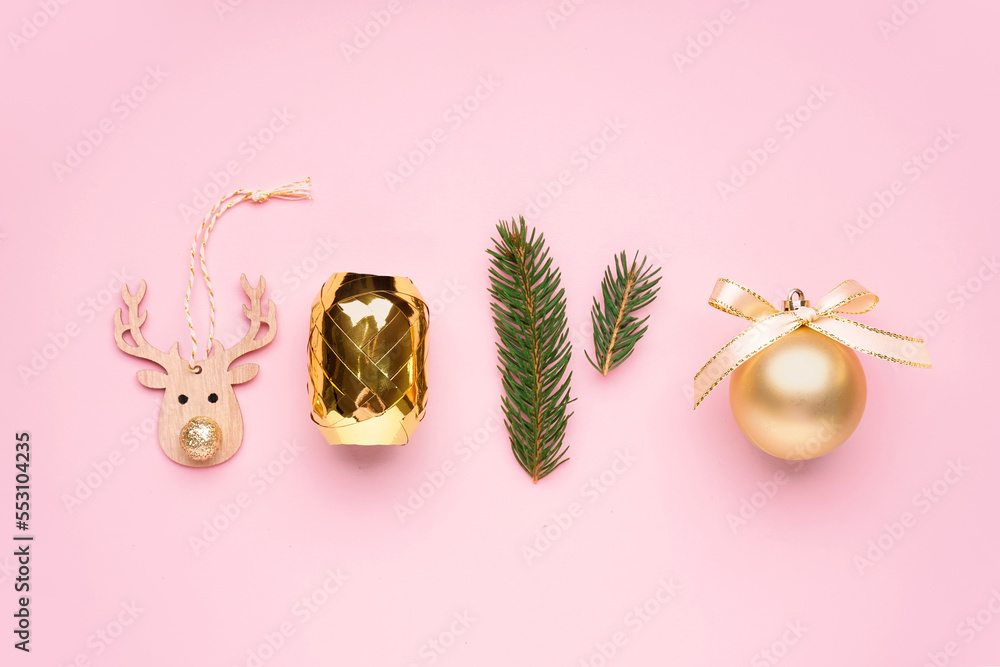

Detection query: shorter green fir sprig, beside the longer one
(584, 250), (660, 375)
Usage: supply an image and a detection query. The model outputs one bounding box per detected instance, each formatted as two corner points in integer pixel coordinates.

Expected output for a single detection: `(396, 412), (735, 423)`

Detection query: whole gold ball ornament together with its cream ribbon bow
(694, 278), (930, 460)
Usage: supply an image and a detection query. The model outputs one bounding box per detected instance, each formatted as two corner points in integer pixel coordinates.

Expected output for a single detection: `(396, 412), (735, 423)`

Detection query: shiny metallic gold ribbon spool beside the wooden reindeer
(309, 273), (429, 445)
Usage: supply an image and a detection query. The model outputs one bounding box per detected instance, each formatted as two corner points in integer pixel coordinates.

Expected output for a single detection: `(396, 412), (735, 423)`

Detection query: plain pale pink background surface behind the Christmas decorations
(0, 0), (1000, 667)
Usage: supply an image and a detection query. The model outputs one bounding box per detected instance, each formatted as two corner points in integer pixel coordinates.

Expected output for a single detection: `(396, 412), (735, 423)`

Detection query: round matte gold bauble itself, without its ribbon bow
(729, 326), (868, 461)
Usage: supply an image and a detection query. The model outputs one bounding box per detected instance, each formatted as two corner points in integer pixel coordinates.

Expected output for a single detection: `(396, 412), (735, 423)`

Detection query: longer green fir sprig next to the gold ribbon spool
(486, 217), (574, 482)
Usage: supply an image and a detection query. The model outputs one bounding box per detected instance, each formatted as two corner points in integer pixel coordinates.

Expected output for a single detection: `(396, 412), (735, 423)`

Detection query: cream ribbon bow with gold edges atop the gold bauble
(694, 278), (931, 408)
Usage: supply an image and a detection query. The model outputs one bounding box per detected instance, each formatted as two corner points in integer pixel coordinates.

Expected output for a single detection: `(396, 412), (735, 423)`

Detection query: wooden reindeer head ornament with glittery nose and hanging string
(115, 179), (309, 467)
